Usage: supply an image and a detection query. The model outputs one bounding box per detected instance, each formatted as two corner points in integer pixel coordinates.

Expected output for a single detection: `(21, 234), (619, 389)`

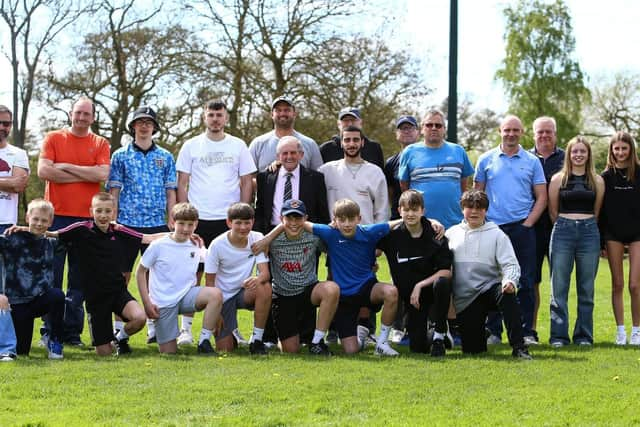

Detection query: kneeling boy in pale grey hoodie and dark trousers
(445, 190), (531, 360)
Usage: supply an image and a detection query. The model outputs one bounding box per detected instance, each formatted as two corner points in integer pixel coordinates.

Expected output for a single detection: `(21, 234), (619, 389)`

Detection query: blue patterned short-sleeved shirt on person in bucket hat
(106, 143), (178, 231)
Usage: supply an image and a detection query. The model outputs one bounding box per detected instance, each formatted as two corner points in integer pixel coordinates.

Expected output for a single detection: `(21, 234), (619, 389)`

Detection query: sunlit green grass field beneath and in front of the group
(0, 261), (640, 426)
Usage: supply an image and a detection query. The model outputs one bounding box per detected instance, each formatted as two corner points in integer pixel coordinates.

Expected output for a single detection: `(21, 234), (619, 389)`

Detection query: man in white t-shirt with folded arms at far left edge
(0, 105), (29, 233)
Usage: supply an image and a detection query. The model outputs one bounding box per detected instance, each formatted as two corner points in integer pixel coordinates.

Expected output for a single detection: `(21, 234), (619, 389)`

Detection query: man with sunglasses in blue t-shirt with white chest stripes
(398, 109), (473, 229)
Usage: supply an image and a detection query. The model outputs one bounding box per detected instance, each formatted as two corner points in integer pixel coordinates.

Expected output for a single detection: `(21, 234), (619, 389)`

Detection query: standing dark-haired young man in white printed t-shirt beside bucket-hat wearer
(176, 100), (256, 344)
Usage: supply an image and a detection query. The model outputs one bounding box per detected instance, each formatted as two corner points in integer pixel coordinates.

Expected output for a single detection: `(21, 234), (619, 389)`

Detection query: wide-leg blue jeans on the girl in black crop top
(549, 217), (600, 344)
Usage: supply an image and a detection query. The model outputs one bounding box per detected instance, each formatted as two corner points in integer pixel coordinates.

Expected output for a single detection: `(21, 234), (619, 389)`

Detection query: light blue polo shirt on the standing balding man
(474, 146), (547, 225)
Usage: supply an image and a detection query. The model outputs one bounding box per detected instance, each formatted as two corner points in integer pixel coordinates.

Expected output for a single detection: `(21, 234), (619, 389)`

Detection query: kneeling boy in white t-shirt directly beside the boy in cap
(204, 203), (271, 354)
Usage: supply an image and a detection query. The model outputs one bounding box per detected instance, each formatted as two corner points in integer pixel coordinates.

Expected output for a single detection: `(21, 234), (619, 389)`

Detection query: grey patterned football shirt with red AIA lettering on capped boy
(269, 231), (323, 296)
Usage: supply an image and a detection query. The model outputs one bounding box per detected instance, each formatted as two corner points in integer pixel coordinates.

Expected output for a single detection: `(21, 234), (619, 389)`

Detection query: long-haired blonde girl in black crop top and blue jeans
(549, 136), (604, 347)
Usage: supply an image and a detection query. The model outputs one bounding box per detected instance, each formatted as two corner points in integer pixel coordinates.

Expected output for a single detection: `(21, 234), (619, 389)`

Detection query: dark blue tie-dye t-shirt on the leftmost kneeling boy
(0, 231), (61, 304)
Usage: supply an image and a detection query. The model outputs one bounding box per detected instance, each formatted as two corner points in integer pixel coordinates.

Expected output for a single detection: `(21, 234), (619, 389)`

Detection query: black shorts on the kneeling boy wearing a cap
(271, 282), (318, 341)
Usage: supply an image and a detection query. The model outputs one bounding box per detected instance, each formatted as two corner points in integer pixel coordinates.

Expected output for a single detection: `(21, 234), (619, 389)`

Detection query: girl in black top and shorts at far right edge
(600, 132), (640, 346)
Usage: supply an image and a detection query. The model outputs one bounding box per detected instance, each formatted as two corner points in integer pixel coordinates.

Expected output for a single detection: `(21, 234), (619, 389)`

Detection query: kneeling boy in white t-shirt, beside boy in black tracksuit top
(136, 203), (222, 355)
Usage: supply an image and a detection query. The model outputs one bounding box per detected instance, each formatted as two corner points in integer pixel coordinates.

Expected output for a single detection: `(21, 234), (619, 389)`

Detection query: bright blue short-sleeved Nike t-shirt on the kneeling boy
(313, 222), (389, 296)
